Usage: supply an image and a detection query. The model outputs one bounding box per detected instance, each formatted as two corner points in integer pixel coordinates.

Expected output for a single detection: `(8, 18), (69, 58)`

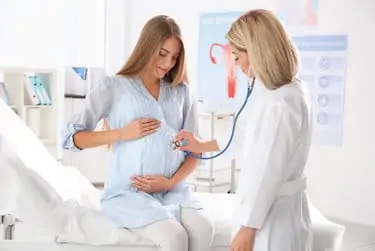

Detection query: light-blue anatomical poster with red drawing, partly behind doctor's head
(197, 12), (247, 112)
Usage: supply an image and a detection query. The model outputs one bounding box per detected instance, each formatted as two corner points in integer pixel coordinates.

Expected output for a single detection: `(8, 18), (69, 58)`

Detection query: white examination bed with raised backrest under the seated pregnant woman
(0, 101), (345, 251)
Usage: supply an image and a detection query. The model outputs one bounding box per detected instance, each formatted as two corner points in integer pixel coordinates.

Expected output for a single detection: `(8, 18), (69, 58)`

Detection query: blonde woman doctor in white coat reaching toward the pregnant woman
(176, 10), (312, 251)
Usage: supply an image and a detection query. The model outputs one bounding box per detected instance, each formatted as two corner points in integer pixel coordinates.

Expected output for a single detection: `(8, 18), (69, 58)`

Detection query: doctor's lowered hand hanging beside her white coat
(230, 226), (256, 251)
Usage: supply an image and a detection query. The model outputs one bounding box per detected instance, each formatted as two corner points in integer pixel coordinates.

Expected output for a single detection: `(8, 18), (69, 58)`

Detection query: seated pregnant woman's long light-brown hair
(103, 15), (188, 148)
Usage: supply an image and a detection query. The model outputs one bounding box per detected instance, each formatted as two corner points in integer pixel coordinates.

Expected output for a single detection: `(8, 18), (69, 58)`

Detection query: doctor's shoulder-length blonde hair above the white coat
(227, 9), (299, 89)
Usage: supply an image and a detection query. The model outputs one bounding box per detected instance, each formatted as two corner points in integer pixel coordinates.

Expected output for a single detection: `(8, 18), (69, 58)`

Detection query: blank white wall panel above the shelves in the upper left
(0, 0), (105, 67)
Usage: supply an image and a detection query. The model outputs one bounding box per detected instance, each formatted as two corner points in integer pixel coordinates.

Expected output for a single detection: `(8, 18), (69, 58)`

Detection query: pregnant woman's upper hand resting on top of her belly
(118, 118), (160, 140)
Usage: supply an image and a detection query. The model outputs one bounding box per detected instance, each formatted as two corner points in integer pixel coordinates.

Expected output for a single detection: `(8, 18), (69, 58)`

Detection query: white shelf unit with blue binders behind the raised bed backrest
(0, 67), (65, 158)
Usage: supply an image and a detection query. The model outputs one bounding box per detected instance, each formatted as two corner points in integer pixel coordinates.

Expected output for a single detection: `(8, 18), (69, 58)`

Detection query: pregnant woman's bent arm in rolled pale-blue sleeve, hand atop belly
(63, 77), (160, 150)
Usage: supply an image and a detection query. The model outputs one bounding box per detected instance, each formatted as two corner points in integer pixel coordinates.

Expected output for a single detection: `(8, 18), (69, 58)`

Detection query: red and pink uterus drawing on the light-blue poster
(209, 43), (237, 99)
